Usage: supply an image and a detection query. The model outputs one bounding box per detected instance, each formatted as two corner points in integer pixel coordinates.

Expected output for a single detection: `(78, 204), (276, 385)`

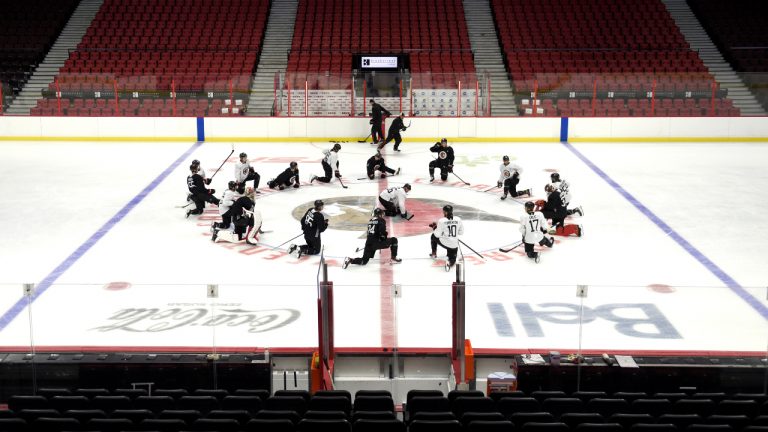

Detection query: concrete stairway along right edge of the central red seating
(463, 0), (518, 116)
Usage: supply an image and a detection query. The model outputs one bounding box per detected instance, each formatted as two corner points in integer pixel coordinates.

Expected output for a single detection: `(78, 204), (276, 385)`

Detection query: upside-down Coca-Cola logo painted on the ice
(91, 304), (301, 333)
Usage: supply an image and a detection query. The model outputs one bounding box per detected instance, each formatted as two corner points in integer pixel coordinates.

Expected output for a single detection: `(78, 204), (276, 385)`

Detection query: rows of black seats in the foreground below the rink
(0, 389), (768, 432)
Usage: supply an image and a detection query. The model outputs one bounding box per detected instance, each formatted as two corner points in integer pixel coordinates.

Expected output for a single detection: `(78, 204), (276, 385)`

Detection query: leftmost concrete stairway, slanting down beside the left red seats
(8, 0), (104, 115)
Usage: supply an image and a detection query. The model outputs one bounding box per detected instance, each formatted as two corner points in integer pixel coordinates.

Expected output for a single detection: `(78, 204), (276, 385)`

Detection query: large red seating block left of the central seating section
(33, 0), (269, 116)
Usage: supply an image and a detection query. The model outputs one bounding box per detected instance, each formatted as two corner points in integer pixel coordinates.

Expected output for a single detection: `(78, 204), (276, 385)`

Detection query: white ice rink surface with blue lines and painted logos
(0, 139), (768, 352)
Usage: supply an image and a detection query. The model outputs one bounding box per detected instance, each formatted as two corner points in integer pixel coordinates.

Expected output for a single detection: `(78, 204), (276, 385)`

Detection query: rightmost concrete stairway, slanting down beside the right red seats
(662, 0), (766, 116)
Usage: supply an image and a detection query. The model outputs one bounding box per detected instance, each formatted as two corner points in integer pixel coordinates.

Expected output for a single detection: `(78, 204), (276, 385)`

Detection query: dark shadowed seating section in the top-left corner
(0, 0), (78, 113)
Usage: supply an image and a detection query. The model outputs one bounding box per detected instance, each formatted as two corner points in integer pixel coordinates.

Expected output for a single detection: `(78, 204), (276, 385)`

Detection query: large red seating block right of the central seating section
(492, 0), (738, 116)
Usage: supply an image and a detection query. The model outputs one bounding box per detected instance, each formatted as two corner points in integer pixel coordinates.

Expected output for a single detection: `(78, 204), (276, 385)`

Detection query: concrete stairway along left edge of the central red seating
(245, 0), (299, 116)
